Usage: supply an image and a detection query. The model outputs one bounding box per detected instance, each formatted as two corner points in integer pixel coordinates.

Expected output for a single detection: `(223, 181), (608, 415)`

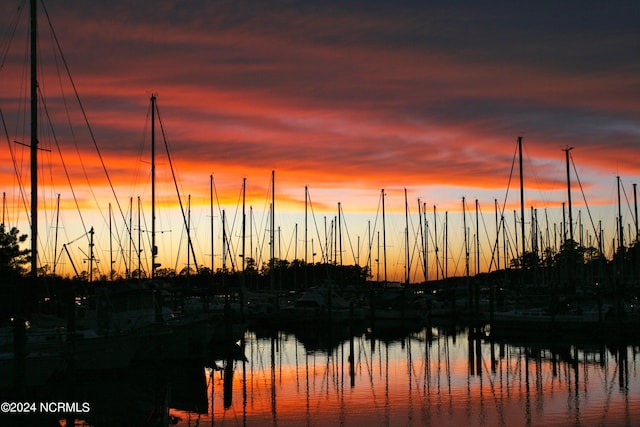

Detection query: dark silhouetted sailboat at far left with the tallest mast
(0, 0), (185, 378)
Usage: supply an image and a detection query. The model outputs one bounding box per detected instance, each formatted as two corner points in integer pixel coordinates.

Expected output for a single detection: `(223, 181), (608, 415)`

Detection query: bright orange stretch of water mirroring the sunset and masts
(170, 327), (640, 426)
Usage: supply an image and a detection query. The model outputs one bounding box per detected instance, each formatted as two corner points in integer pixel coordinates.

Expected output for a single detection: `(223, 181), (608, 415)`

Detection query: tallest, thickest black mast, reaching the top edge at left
(30, 0), (38, 277)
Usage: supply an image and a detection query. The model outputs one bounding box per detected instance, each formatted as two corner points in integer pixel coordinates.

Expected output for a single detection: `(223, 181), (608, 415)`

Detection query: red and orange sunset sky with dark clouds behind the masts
(0, 0), (640, 281)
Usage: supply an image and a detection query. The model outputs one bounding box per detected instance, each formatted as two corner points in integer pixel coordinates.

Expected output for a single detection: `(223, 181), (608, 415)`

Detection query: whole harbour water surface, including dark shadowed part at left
(2, 324), (640, 427)
